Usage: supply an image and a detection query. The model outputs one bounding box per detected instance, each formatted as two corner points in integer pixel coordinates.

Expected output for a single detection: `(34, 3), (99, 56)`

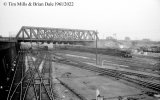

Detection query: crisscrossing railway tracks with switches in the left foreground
(7, 50), (58, 100)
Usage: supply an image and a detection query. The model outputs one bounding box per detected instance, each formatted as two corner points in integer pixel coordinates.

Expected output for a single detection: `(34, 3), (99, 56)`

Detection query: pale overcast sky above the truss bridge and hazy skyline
(0, 0), (160, 41)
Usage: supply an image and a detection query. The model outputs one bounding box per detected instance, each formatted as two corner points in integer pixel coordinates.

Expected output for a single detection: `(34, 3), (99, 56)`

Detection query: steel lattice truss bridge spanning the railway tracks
(16, 26), (99, 43)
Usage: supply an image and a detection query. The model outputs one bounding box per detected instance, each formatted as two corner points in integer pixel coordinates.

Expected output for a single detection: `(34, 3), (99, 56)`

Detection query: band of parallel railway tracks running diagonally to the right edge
(49, 54), (160, 93)
